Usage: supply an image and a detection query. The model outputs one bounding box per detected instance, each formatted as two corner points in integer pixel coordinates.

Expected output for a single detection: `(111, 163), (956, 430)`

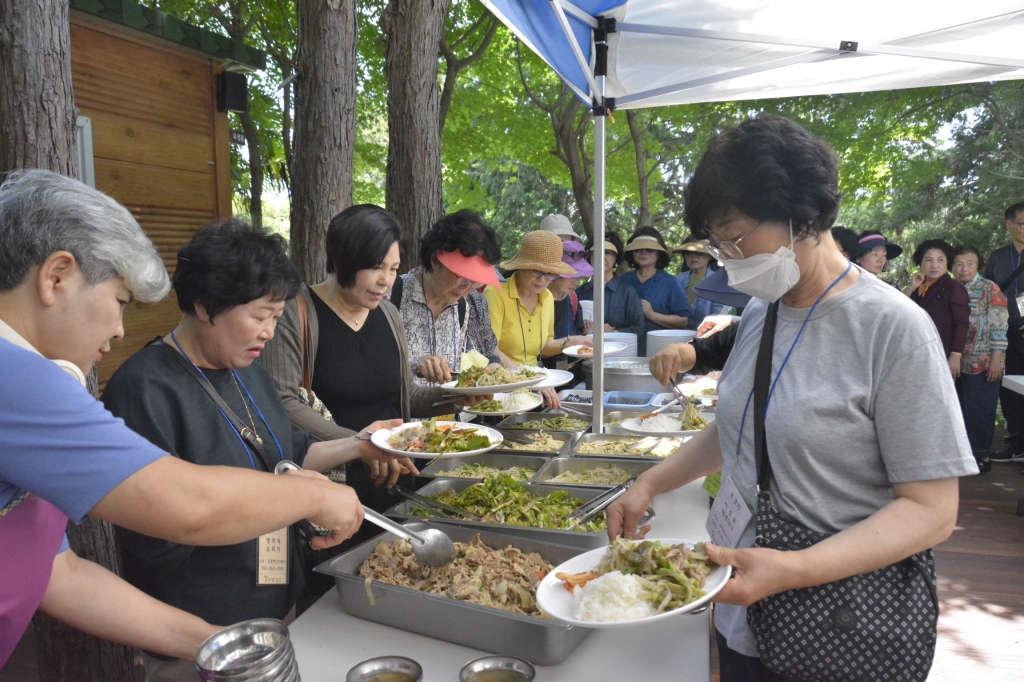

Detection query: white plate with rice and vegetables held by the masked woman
(537, 538), (732, 628)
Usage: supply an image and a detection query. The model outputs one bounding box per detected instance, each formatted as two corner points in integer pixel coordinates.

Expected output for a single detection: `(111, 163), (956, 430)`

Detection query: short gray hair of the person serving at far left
(0, 170), (171, 302)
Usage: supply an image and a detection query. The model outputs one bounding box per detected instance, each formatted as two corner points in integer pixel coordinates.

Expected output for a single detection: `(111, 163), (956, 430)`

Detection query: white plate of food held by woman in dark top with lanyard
(370, 420), (505, 460)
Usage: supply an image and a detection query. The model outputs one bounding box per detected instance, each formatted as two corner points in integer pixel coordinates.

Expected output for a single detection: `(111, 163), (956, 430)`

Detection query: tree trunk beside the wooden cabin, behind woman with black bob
(291, 0), (358, 284)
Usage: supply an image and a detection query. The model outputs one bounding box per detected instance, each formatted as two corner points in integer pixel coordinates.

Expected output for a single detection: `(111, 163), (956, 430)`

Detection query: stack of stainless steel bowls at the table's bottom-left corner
(196, 619), (298, 682)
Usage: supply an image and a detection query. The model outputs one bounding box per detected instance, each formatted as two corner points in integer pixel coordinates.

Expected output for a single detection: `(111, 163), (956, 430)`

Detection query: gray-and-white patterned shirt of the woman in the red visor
(388, 266), (498, 386)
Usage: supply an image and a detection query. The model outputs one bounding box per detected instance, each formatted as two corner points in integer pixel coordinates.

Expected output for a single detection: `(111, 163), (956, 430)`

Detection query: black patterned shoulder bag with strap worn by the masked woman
(746, 302), (939, 682)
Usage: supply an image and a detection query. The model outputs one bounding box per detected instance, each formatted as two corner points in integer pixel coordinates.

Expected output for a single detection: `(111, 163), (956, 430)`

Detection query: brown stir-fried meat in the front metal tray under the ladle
(359, 535), (552, 617)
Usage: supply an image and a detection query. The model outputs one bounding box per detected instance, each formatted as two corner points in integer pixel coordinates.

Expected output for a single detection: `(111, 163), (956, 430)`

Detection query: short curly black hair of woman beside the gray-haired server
(172, 218), (302, 323)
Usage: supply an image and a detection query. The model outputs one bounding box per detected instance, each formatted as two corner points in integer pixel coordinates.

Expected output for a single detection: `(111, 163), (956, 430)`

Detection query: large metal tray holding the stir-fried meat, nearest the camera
(314, 522), (593, 666)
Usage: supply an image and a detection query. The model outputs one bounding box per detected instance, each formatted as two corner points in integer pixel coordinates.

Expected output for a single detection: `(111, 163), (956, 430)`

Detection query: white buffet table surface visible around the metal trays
(290, 479), (711, 682)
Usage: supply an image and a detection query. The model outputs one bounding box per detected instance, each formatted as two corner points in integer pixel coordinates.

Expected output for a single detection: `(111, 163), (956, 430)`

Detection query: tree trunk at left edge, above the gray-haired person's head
(0, 0), (78, 177)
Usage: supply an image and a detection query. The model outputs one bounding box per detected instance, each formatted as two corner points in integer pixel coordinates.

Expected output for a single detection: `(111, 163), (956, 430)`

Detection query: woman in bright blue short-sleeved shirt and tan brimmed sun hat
(623, 225), (690, 354)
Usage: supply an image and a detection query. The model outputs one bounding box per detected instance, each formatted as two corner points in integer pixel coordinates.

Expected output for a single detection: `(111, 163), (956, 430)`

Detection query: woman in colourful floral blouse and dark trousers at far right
(953, 246), (1008, 473)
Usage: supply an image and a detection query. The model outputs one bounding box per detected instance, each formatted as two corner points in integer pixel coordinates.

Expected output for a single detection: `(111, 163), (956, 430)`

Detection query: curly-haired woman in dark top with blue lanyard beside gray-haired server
(103, 221), (392, 678)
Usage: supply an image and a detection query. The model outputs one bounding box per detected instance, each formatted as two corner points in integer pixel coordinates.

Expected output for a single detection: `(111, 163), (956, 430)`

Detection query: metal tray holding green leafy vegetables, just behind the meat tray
(384, 478), (608, 550)
